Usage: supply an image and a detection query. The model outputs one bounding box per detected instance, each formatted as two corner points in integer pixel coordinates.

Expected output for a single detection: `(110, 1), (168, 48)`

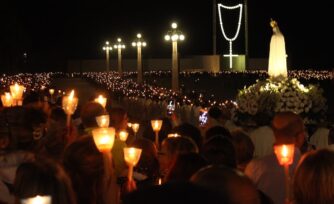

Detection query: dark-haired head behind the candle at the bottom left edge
(14, 155), (76, 204)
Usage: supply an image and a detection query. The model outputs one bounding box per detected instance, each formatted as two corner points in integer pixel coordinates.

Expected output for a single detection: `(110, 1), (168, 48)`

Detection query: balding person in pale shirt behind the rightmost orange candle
(245, 112), (305, 204)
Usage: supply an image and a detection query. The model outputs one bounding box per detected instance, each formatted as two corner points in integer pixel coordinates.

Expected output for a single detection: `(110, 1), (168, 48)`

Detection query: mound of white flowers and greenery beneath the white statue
(236, 78), (327, 122)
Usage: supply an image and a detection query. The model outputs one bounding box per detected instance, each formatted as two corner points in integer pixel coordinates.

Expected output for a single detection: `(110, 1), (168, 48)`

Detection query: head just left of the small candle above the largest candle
(80, 101), (106, 128)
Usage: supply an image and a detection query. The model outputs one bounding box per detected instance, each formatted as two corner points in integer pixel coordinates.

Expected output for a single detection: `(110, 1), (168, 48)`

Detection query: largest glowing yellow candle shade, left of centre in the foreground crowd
(92, 128), (115, 153)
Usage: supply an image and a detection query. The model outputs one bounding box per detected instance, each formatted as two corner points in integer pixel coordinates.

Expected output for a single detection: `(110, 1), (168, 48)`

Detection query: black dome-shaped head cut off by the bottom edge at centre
(122, 182), (227, 204)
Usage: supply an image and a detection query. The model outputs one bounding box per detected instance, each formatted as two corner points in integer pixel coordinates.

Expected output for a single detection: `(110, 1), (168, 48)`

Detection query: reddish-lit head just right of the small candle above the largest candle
(109, 107), (128, 131)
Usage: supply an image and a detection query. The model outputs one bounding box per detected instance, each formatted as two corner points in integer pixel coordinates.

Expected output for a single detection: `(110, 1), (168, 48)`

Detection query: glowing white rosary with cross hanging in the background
(218, 4), (242, 68)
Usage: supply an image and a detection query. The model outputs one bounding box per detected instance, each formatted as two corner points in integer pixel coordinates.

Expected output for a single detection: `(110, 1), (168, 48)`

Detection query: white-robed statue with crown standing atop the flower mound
(268, 23), (288, 77)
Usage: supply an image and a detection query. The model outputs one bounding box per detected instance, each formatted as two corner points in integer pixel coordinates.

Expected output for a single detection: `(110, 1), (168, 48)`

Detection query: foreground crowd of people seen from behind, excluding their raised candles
(0, 85), (334, 204)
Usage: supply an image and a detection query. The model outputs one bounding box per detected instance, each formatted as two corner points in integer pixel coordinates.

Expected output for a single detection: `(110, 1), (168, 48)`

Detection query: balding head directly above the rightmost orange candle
(272, 112), (305, 148)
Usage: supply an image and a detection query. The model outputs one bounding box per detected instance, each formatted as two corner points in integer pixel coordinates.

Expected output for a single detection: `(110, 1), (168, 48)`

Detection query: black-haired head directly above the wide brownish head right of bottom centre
(201, 135), (237, 168)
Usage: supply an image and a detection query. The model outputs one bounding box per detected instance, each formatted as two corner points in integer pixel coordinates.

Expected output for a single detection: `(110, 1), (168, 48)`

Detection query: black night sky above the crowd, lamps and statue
(0, 0), (334, 71)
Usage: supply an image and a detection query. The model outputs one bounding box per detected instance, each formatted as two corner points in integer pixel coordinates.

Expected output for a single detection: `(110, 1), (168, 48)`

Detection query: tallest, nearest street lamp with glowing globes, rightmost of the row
(165, 23), (184, 91)
